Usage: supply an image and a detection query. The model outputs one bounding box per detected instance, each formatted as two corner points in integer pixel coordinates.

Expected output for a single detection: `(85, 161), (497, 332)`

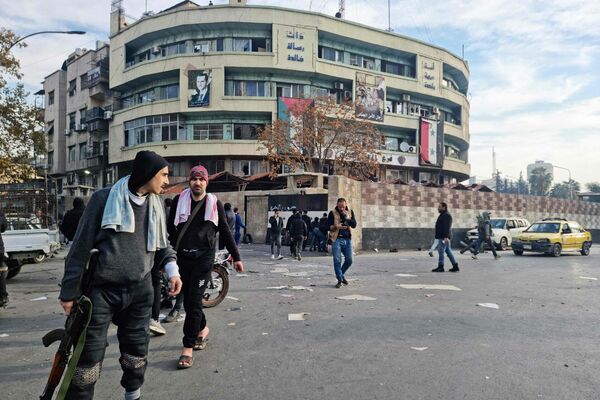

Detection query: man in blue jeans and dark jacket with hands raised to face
(327, 198), (356, 289)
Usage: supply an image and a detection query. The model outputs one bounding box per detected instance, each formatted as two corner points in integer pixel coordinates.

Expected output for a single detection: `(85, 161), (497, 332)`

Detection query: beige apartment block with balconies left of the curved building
(43, 42), (113, 202)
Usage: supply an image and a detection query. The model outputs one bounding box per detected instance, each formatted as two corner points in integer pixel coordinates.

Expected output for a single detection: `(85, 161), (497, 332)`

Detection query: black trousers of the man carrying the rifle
(65, 274), (153, 400)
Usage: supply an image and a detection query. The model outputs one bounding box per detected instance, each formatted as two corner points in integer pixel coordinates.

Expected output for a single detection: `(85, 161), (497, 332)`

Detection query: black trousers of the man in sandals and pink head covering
(178, 250), (215, 348)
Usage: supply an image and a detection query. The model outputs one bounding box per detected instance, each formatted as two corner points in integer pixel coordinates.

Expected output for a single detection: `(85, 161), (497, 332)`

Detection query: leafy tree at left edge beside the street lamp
(0, 28), (46, 182)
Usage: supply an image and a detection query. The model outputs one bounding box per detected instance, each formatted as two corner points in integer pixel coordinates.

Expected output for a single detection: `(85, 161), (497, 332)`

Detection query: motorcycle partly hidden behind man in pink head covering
(161, 250), (233, 308)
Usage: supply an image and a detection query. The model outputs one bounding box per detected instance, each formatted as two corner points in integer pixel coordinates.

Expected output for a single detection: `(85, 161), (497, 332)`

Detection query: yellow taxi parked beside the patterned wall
(512, 218), (592, 257)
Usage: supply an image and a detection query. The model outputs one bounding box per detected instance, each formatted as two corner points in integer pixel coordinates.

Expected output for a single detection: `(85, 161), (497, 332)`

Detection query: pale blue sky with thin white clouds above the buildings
(0, 0), (600, 183)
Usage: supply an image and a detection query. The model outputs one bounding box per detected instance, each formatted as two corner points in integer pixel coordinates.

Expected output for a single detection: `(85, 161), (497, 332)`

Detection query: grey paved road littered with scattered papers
(0, 245), (600, 400)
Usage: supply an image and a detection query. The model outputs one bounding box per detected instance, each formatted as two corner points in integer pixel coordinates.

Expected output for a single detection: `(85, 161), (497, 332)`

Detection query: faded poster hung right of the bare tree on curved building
(354, 72), (385, 121)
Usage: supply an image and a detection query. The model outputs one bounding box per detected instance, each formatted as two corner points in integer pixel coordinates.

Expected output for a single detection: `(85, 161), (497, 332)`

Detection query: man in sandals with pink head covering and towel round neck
(167, 165), (244, 369)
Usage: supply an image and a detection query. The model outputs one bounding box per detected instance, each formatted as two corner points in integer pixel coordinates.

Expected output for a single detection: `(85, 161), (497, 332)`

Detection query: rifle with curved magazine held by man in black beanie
(40, 249), (99, 400)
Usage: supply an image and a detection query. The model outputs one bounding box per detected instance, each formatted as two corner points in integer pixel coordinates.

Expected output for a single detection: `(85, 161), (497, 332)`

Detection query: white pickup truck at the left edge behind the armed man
(2, 217), (60, 279)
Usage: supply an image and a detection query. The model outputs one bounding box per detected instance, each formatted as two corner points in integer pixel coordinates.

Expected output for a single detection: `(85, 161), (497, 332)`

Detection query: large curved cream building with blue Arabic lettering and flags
(110, 0), (470, 183)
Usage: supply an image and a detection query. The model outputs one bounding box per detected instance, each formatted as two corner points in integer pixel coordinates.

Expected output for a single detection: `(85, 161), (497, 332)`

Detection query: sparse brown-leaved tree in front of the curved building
(258, 97), (383, 180)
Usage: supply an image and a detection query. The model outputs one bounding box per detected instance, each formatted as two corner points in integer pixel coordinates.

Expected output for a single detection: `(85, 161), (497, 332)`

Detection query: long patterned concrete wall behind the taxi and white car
(329, 177), (600, 249)
